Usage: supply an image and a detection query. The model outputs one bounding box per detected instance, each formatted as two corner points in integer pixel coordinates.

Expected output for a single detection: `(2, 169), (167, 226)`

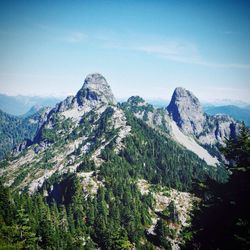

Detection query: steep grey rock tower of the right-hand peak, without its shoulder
(167, 87), (206, 135)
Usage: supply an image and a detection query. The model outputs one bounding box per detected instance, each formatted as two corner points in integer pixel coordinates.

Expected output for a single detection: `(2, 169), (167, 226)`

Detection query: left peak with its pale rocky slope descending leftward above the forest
(1, 74), (131, 193)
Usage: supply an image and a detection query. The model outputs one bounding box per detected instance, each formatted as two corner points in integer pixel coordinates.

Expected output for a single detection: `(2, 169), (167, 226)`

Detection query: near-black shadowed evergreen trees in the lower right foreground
(187, 124), (250, 250)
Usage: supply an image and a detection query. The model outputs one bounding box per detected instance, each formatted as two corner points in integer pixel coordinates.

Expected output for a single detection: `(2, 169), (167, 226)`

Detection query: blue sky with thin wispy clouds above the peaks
(0, 0), (250, 101)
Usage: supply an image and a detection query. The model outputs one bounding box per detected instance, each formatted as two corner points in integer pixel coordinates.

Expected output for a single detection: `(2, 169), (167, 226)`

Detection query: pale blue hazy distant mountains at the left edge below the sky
(0, 94), (60, 116)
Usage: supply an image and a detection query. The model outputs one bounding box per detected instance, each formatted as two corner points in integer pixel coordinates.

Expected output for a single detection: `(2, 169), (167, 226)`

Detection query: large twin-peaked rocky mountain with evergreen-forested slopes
(0, 73), (242, 249)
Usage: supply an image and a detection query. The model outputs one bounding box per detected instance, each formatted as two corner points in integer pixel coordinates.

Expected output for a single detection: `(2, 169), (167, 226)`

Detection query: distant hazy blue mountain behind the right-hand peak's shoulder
(204, 105), (250, 126)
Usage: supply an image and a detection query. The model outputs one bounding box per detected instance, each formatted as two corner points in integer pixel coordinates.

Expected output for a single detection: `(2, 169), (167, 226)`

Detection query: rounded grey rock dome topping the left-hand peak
(76, 73), (116, 106)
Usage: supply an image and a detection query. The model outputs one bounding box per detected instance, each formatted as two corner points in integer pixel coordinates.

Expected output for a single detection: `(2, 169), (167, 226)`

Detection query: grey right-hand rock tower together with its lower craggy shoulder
(167, 88), (240, 146)
